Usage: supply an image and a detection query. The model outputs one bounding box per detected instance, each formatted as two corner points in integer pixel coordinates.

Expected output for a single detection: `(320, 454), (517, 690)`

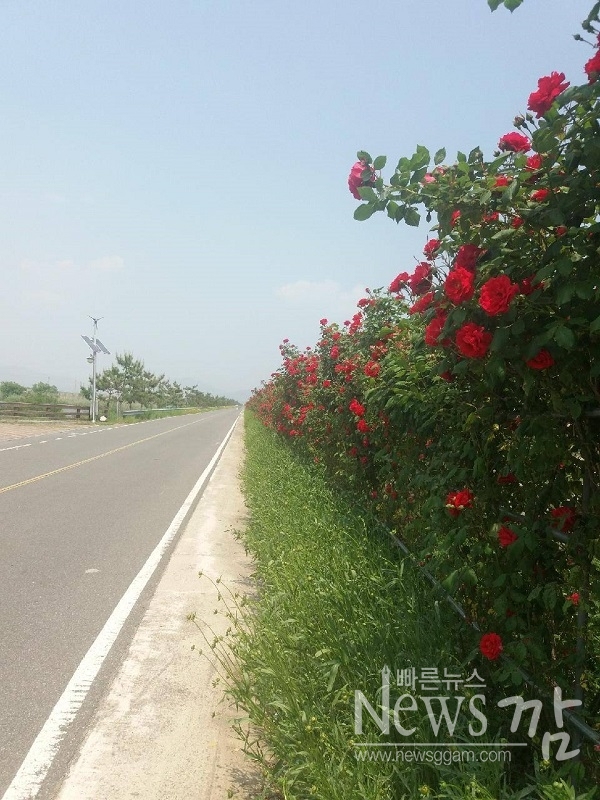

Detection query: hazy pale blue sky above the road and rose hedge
(0, 0), (592, 399)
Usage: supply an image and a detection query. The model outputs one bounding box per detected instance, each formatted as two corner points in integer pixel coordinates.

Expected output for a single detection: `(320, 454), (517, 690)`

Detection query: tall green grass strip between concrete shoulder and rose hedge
(200, 415), (596, 800)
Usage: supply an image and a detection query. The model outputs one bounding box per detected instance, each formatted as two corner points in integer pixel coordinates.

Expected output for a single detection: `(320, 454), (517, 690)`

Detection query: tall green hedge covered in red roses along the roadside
(250, 4), (600, 764)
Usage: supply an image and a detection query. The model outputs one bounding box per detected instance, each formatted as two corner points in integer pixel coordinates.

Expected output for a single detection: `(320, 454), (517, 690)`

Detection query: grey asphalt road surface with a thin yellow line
(0, 409), (239, 797)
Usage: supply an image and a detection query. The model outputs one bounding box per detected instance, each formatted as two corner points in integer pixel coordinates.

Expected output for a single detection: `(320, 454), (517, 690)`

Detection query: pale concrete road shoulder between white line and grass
(57, 419), (257, 800)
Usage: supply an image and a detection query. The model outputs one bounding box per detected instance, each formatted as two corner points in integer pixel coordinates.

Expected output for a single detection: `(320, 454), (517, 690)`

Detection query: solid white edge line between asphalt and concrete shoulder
(2, 417), (239, 800)
